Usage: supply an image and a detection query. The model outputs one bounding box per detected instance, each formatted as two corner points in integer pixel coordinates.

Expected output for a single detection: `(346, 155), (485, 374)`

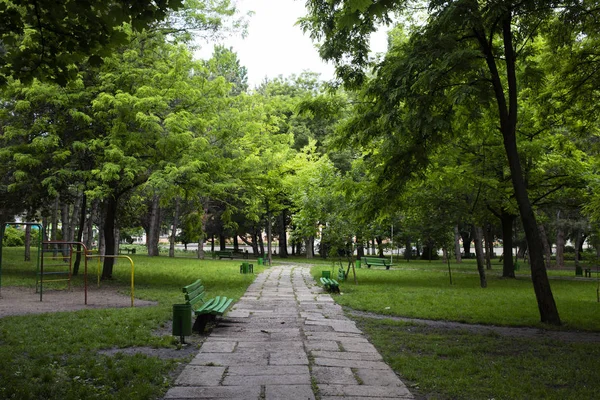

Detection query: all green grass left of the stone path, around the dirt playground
(0, 248), (263, 399)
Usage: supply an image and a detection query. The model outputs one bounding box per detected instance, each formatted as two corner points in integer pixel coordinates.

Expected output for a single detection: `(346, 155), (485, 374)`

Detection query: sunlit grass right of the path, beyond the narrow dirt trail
(312, 261), (600, 331)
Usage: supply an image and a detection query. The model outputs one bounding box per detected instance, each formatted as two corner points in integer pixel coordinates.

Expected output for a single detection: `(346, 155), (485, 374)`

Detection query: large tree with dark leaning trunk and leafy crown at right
(301, 0), (599, 325)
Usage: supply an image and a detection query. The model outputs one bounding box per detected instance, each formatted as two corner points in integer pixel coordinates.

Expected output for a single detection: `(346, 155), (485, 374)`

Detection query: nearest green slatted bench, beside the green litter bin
(182, 279), (233, 332)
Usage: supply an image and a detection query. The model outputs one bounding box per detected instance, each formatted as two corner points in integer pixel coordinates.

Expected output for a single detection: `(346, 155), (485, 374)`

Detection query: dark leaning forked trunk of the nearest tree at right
(474, 16), (561, 325)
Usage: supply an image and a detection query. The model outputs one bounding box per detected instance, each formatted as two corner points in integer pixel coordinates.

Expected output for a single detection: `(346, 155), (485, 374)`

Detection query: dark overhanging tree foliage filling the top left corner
(0, 0), (183, 85)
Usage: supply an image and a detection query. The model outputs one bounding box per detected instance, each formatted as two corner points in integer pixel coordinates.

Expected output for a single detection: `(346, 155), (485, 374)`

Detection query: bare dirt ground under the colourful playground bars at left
(0, 285), (157, 318)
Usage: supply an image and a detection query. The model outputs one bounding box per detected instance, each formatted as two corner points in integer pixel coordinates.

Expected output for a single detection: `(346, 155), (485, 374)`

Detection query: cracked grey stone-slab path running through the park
(165, 265), (413, 400)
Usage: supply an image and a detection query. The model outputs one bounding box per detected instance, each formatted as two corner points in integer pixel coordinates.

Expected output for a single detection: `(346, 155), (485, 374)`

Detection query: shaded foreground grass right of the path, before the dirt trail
(357, 318), (600, 400)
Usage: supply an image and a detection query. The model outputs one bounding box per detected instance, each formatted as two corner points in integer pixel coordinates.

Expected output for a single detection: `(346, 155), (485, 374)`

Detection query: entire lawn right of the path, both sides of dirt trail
(312, 260), (600, 400)
